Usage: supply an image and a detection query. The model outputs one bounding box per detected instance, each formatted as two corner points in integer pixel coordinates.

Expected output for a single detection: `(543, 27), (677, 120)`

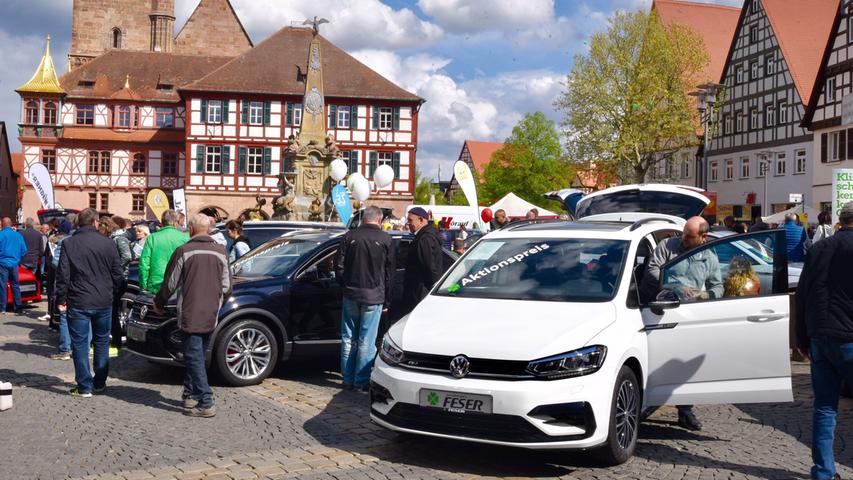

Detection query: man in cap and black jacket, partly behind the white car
(399, 207), (444, 315)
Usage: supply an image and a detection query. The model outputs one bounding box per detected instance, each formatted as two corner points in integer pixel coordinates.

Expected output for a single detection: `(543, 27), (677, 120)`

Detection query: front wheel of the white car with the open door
(596, 365), (642, 466)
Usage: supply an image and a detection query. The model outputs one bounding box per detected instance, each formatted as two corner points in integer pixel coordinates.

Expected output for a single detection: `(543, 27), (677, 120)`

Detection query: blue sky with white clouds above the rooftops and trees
(0, 0), (742, 179)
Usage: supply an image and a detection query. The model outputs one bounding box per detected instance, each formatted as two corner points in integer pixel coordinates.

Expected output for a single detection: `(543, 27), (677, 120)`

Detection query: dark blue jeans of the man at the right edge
(809, 337), (853, 480)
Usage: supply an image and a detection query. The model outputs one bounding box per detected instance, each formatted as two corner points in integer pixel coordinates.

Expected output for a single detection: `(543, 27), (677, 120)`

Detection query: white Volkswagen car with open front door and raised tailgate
(370, 185), (792, 465)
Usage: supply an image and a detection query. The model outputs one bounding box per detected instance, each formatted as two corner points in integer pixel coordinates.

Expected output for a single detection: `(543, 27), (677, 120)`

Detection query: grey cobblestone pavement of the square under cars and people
(0, 302), (853, 480)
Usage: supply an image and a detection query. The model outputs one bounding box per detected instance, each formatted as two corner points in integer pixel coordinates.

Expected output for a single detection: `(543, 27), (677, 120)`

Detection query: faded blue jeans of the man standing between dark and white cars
(341, 297), (382, 387)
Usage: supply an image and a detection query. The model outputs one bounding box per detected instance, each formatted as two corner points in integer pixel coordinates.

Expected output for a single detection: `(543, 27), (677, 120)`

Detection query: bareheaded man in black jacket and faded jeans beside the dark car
(335, 207), (394, 391)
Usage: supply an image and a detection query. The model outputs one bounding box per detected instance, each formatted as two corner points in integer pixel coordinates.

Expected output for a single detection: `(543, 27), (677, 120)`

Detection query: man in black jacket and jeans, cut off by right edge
(796, 202), (853, 480)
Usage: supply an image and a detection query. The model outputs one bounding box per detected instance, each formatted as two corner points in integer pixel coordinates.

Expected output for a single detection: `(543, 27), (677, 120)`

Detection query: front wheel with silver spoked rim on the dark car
(213, 320), (278, 387)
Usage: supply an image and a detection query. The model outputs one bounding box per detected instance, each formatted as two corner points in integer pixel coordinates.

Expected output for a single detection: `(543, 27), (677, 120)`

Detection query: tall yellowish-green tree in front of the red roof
(555, 11), (709, 183)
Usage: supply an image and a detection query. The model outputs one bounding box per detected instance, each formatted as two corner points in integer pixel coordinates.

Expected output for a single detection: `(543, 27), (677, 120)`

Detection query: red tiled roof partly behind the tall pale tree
(652, 0), (740, 83)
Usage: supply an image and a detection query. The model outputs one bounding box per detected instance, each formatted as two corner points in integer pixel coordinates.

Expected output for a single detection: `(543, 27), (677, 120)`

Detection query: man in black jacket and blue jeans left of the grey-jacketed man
(56, 208), (123, 398)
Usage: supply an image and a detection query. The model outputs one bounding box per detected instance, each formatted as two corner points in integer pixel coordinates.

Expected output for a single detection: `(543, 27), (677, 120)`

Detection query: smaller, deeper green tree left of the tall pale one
(479, 112), (574, 211)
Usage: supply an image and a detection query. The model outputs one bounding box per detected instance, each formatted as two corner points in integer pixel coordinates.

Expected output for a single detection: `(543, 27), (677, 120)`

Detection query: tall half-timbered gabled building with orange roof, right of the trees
(708, 0), (839, 219)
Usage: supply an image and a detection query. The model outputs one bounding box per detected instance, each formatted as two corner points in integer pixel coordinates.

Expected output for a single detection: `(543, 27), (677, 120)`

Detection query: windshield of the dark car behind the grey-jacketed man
(231, 238), (320, 277)
